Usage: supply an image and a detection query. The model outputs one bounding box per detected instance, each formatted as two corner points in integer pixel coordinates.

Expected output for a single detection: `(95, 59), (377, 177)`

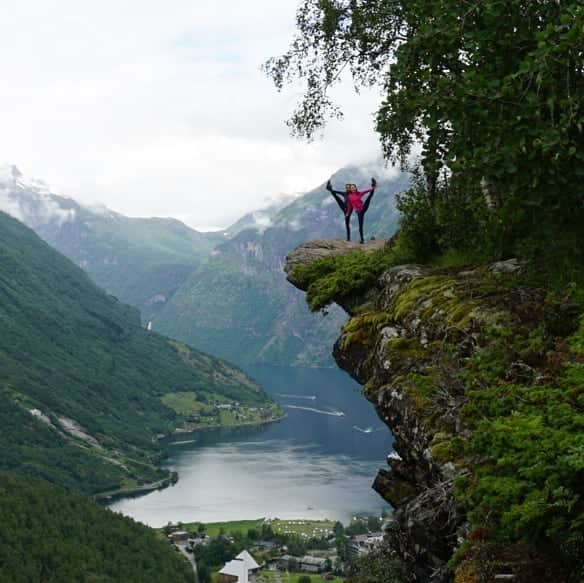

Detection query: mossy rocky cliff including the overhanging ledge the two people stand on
(286, 240), (578, 583)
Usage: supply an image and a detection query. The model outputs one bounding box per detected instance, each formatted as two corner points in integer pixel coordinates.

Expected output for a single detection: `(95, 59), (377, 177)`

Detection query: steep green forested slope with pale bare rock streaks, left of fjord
(0, 213), (265, 493)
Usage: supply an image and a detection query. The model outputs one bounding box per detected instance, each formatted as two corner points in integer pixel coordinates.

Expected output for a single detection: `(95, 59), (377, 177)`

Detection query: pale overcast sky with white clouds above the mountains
(0, 0), (380, 229)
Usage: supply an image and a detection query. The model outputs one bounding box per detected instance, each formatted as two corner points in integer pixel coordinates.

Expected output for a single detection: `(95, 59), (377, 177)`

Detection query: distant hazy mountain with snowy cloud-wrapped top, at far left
(0, 166), (224, 321)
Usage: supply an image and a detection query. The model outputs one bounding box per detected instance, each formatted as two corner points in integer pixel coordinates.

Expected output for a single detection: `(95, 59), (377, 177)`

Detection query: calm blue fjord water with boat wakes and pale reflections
(111, 367), (392, 526)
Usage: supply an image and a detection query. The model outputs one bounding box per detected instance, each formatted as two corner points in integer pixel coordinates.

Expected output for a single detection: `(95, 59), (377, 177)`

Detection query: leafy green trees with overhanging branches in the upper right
(265, 0), (584, 255)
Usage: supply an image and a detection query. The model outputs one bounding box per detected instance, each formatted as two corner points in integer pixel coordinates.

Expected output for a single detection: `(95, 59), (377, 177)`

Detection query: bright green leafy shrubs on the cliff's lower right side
(458, 312), (584, 580)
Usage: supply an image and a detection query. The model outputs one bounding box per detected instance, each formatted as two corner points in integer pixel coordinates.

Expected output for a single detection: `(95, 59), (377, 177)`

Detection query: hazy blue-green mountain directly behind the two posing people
(154, 167), (409, 366)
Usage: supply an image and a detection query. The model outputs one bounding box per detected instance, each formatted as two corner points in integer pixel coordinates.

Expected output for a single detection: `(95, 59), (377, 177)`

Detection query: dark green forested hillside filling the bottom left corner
(0, 472), (194, 583)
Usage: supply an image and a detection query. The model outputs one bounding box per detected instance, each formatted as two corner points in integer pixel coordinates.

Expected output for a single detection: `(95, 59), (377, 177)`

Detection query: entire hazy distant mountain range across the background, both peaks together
(0, 164), (409, 366)
